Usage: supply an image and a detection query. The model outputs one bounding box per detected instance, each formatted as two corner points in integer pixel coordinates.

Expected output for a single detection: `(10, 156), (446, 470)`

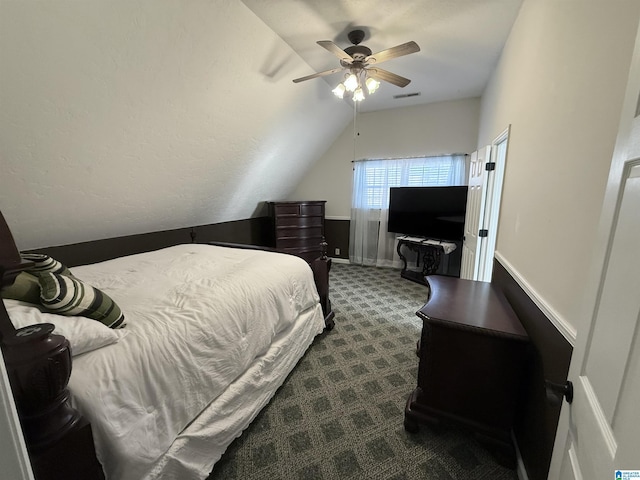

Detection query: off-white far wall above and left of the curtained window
(290, 96), (480, 218)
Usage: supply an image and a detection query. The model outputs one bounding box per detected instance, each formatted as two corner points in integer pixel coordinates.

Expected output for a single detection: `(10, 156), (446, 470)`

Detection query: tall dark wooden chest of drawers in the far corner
(269, 200), (326, 263)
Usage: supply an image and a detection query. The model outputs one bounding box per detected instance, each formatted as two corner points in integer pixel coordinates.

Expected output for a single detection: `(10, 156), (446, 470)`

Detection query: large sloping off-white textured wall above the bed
(0, 0), (351, 249)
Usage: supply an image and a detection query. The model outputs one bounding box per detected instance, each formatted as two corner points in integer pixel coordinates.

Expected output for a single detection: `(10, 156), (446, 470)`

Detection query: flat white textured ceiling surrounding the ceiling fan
(243, 0), (522, 112)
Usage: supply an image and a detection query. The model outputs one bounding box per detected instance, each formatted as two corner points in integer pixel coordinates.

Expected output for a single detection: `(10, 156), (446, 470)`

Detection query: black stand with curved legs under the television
(396, 235), (457, 285)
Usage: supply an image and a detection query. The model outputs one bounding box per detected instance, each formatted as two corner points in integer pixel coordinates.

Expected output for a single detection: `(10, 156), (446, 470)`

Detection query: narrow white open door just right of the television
(460, 145), (491, 280)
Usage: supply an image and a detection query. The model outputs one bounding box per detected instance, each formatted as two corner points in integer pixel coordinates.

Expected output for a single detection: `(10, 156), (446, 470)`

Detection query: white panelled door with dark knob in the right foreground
(549, 21), (640, 480)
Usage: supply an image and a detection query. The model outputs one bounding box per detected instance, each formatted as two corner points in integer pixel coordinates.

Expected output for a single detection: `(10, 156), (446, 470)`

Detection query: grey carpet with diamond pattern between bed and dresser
(209, 264), (517, 480)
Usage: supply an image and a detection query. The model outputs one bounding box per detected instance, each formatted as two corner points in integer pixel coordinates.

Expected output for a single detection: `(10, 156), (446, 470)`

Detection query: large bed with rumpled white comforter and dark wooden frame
(0, 215), (326, 480)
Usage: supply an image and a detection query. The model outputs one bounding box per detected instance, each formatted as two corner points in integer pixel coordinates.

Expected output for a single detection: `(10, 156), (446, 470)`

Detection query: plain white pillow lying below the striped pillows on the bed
(4, 300), (129, 356)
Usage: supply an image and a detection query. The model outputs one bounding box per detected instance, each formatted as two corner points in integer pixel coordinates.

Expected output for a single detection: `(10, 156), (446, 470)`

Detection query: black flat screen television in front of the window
(387, 186), (467, 241)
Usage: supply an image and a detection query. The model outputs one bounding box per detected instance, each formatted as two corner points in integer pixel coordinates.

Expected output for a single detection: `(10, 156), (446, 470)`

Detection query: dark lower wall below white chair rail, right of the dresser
(491, 259), (573, 480)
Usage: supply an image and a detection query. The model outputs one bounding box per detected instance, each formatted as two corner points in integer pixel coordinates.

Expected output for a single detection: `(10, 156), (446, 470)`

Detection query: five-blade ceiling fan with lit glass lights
(293, 30), (420, 101)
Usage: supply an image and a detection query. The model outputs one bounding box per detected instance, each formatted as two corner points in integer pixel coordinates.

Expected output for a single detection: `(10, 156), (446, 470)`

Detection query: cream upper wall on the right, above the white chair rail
(478, 0), (640, 338)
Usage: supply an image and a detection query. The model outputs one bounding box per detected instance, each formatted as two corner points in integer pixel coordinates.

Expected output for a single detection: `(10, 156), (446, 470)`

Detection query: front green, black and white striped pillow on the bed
(38, 272), (124, 328)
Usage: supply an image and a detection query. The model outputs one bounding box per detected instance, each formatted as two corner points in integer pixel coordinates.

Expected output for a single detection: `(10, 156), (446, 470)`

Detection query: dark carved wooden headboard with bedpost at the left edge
(0, 212), (104, 480)
